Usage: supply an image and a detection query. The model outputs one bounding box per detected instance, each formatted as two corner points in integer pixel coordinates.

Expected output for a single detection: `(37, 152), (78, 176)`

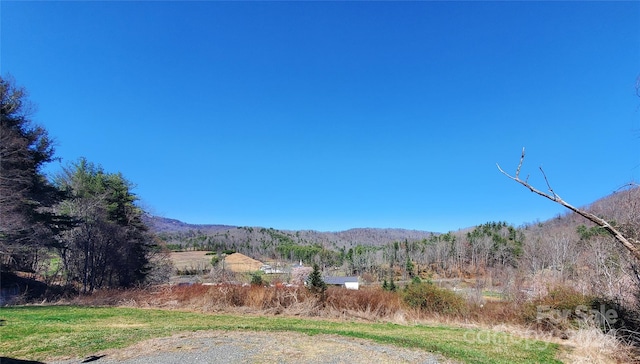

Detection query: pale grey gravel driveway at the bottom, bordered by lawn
(49, 331), (453, 364)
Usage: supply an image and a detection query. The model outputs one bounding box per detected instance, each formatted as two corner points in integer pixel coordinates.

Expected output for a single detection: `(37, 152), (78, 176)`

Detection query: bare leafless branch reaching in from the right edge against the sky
(496, 148), (640, 262)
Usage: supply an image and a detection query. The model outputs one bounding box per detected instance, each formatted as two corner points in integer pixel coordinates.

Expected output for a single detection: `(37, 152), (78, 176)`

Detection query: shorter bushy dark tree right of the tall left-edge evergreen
(56, 159), (155, 292)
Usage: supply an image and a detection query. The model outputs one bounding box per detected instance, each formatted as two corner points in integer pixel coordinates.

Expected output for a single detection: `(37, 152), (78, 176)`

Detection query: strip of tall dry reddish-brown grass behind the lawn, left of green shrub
(69, 284), (406, 321)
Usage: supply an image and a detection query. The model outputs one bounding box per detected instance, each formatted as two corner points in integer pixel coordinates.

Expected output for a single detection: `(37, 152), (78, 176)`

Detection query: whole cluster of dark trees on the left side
(0, 78), (166, 292)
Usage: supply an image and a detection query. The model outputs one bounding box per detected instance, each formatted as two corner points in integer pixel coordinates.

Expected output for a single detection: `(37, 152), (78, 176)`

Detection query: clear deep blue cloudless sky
(0, 1), (640, 232)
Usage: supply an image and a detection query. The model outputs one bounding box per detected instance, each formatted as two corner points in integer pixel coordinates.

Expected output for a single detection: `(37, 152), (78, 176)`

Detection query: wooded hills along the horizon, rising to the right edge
(150, 183), (640, 306)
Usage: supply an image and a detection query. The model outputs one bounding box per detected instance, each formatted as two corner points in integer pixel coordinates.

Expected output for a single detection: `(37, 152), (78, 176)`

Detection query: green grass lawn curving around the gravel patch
(0, 306), (560, 363)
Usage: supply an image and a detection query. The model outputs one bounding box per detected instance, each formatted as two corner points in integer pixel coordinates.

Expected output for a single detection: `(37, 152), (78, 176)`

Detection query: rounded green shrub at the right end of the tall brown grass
(403, 281), (467, 314)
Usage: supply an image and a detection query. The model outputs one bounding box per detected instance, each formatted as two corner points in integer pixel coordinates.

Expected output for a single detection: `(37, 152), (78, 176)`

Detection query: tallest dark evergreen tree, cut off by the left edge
(0, 77), (69, 271)
